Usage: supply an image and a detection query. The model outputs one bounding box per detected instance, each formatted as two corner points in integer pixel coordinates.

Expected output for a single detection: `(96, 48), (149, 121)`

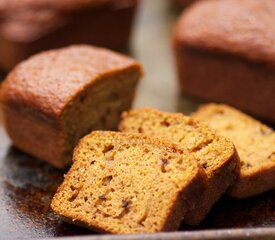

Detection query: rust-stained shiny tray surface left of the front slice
(0, 147), (94, 239)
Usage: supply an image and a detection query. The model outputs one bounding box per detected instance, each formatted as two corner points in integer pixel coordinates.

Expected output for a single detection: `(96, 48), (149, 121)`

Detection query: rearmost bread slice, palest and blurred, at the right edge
(193, 104), (275, 198)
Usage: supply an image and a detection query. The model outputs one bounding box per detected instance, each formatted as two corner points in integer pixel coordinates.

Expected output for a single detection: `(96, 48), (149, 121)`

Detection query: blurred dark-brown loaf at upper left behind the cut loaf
(0, 0), (138, 70)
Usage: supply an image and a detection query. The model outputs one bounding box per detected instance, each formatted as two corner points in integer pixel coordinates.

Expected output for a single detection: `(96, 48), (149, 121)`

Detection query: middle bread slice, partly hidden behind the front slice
(119, 108), (238, 225)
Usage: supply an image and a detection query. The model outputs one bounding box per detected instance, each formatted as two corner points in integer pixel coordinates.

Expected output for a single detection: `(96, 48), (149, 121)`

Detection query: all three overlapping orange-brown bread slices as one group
(51, 104), (275, 233)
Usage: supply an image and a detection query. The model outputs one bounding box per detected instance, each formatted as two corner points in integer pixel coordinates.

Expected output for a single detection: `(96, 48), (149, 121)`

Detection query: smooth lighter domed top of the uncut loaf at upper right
(174, 0), (275, 66)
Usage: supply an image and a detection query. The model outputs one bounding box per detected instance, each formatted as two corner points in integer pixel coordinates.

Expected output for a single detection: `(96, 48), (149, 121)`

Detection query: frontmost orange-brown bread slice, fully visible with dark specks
(51, 131), (206, 233)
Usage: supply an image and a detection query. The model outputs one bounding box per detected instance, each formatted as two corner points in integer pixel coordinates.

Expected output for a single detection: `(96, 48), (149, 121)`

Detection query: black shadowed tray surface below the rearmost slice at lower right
(181, 191), (275, 230)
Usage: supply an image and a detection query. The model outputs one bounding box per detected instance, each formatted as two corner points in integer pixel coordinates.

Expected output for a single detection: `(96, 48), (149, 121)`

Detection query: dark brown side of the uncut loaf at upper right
(175, 47), (275, 122)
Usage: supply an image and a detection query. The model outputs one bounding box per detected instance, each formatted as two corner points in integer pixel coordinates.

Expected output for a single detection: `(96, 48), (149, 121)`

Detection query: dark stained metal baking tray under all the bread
(0, 0), (275, 239)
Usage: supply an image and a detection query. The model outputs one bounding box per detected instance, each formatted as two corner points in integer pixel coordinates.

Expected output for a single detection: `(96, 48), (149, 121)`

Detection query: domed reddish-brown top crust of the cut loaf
(1, 45), (142, 123)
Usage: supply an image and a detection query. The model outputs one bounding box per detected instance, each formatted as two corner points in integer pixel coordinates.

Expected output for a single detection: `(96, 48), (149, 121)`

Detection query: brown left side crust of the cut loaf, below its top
(2, 106), (65, 168)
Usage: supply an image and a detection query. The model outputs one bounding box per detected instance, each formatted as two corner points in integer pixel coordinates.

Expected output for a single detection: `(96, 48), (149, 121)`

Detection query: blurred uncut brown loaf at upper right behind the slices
(173, 0), (275, 122)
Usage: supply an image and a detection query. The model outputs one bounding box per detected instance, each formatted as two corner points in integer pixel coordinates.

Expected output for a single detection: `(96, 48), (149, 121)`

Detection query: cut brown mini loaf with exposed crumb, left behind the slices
(0, 45), (142, 168)
